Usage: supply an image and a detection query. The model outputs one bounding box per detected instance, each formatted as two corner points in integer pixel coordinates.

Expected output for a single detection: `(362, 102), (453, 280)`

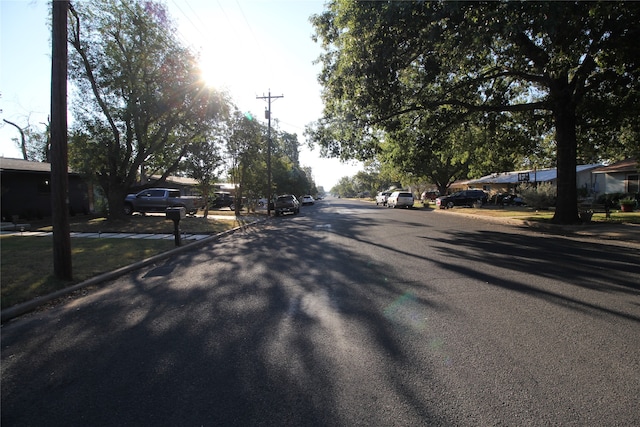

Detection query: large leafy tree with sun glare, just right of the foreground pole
(69, 0), (227, 216)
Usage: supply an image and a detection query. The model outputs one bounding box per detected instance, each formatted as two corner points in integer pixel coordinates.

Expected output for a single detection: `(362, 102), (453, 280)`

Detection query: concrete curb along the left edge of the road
(0, 219), (267, 324)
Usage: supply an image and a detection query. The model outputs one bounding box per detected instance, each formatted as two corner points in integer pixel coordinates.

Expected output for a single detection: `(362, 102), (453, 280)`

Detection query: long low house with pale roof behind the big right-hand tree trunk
(465, 164), (602, 195)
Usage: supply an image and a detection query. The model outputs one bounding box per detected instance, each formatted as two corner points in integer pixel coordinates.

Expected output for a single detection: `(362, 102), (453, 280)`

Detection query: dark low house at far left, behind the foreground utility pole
(0, 157), (90, 222)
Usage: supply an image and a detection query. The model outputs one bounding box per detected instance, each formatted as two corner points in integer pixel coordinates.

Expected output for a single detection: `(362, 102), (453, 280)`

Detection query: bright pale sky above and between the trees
(0, 0), (361, 191)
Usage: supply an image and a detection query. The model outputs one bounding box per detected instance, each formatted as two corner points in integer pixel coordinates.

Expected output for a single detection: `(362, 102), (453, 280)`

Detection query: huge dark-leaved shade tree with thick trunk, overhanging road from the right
(308, 1), (640, 223)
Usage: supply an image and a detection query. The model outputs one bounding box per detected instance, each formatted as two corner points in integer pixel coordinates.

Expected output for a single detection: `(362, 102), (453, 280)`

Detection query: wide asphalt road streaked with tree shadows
(1, 199), (640, 426)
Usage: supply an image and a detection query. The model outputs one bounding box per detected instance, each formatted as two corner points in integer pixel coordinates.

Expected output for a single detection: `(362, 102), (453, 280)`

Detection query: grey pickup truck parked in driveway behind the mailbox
(124, 188), (202, 215)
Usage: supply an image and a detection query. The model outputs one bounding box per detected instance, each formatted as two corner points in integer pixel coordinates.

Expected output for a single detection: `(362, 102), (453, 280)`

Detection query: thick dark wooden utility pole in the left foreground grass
(50, 0), (72, 280)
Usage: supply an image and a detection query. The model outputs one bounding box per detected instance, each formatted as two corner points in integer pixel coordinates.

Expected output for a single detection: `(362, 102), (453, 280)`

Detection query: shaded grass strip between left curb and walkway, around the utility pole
(0, 236), (175, 309)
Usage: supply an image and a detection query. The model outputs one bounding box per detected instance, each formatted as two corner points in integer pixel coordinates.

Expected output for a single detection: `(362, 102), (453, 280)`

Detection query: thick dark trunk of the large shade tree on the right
(551, 78), (580, 224)
